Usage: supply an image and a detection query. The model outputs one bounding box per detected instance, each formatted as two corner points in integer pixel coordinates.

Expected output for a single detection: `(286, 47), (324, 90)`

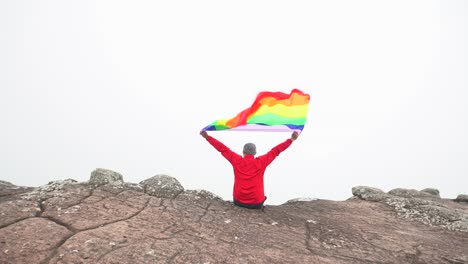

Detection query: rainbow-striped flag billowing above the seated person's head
(202, 89), (310, 132)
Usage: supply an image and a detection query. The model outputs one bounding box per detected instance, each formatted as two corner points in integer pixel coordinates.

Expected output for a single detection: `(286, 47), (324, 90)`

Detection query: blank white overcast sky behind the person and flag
(0, 0), (468, 204)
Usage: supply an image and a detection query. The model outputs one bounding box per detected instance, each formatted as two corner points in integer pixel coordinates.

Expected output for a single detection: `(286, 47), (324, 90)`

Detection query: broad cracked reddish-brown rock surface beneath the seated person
(0, 176), (468, 264)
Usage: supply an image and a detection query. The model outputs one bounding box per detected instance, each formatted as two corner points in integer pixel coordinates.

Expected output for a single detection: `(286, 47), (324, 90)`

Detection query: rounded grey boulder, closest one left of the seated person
(140, 174), (184, 199)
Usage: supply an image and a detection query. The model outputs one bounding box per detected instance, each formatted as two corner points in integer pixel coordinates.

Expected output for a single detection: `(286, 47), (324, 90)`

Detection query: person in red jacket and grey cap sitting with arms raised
(200, 131), (299, 209)
